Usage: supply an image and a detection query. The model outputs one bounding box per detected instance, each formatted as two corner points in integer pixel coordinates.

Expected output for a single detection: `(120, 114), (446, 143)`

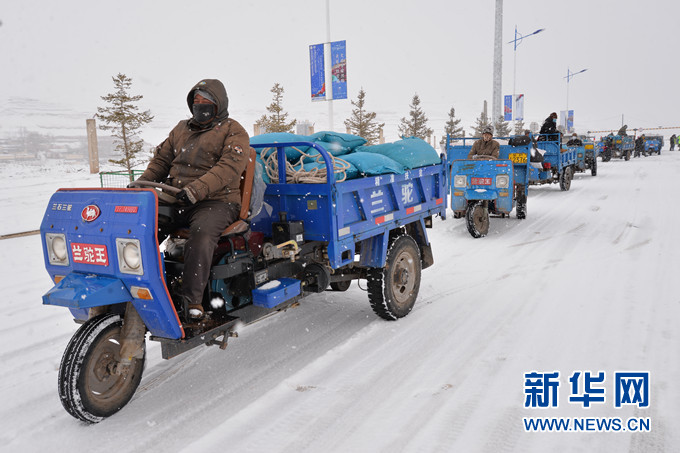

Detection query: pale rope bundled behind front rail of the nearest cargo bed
(260, 146), (350, 184)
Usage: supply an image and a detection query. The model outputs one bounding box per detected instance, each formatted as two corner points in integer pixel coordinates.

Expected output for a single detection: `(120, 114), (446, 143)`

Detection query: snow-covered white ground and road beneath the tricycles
(0, 151), (680, 453)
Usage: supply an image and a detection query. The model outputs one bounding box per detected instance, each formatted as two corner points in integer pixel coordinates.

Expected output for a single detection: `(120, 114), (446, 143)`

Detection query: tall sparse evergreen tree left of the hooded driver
(95, 73), (153, 174)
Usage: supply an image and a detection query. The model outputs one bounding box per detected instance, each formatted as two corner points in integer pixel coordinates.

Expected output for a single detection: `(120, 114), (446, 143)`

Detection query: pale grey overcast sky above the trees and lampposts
(0, 0), (680, 143)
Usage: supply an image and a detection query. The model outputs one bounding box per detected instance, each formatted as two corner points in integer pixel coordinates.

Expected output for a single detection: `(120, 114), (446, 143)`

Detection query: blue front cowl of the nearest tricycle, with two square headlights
(40, 189), (184, 339)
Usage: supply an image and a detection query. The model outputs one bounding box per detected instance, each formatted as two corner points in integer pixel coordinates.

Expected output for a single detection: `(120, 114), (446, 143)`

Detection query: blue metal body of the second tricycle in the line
(447, 138), (531, 214)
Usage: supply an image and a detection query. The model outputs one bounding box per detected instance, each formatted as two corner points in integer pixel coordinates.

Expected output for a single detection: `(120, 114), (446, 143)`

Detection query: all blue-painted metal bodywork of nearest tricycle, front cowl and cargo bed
(40, 143), (448, 340)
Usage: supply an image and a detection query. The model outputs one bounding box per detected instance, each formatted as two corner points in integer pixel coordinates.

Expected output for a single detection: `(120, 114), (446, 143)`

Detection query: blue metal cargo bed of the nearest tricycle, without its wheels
(251, 142), (448, 269)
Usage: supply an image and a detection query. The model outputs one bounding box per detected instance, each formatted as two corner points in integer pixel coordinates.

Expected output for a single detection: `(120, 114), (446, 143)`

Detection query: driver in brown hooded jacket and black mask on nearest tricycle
(139, 79), (250, 319)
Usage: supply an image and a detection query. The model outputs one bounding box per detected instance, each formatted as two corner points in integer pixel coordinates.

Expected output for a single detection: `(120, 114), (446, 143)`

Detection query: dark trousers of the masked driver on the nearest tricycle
(158, 201), (240, 304)
